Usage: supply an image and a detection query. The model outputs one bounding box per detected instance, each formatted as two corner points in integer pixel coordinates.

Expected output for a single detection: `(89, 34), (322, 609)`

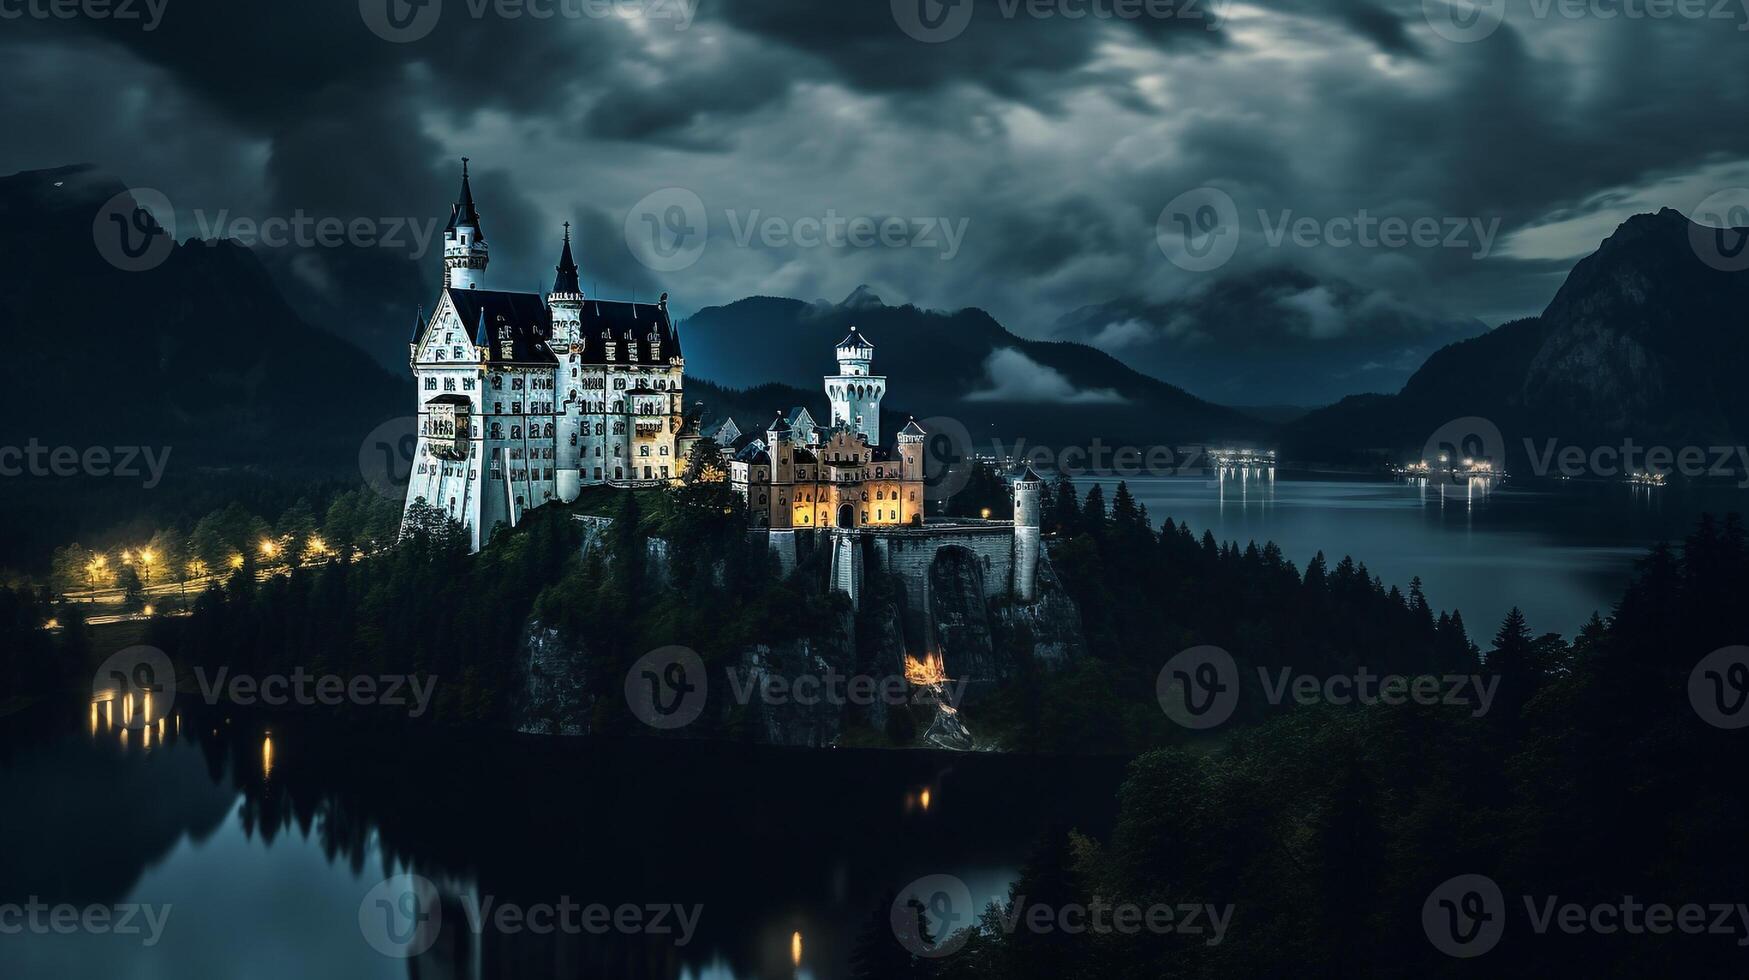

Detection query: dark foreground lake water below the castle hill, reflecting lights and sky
(0, 705), (1125, 980)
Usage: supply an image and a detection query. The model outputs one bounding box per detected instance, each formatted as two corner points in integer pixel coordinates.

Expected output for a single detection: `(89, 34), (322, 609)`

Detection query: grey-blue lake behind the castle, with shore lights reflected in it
(1077, 471), (1749, 646)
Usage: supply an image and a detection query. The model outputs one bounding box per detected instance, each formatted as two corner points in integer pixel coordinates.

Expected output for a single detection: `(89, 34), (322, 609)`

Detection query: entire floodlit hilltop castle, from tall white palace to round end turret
(406, 158), (1042, 602)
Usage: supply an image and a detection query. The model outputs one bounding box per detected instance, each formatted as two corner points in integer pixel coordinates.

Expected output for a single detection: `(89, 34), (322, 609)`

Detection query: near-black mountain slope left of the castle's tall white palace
(0, 166), (411, 473)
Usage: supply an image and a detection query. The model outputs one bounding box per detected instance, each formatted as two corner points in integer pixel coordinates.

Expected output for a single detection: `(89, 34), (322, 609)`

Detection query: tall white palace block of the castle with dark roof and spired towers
(408, 161), (686, 550)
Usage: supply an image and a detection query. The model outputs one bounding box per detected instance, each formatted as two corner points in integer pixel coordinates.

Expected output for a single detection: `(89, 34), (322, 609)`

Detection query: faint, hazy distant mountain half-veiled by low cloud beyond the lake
(1051, 266), (1488, 406)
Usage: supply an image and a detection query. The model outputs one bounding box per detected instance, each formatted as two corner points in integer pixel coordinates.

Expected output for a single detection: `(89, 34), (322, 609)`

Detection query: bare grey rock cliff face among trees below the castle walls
(516, 553), (1086, 749)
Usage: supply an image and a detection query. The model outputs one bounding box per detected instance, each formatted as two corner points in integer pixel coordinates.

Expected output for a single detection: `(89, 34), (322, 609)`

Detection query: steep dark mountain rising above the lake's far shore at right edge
(1284, 208), (1749, 466)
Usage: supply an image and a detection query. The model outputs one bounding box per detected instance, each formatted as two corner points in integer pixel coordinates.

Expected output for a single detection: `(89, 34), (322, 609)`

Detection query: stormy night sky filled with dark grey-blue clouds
(0, 0), (1749, 404)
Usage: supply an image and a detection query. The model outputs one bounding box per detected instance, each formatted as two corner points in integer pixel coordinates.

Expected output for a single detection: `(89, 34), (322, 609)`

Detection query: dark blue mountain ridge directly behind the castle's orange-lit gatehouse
(682, 287), (1270, 450)
